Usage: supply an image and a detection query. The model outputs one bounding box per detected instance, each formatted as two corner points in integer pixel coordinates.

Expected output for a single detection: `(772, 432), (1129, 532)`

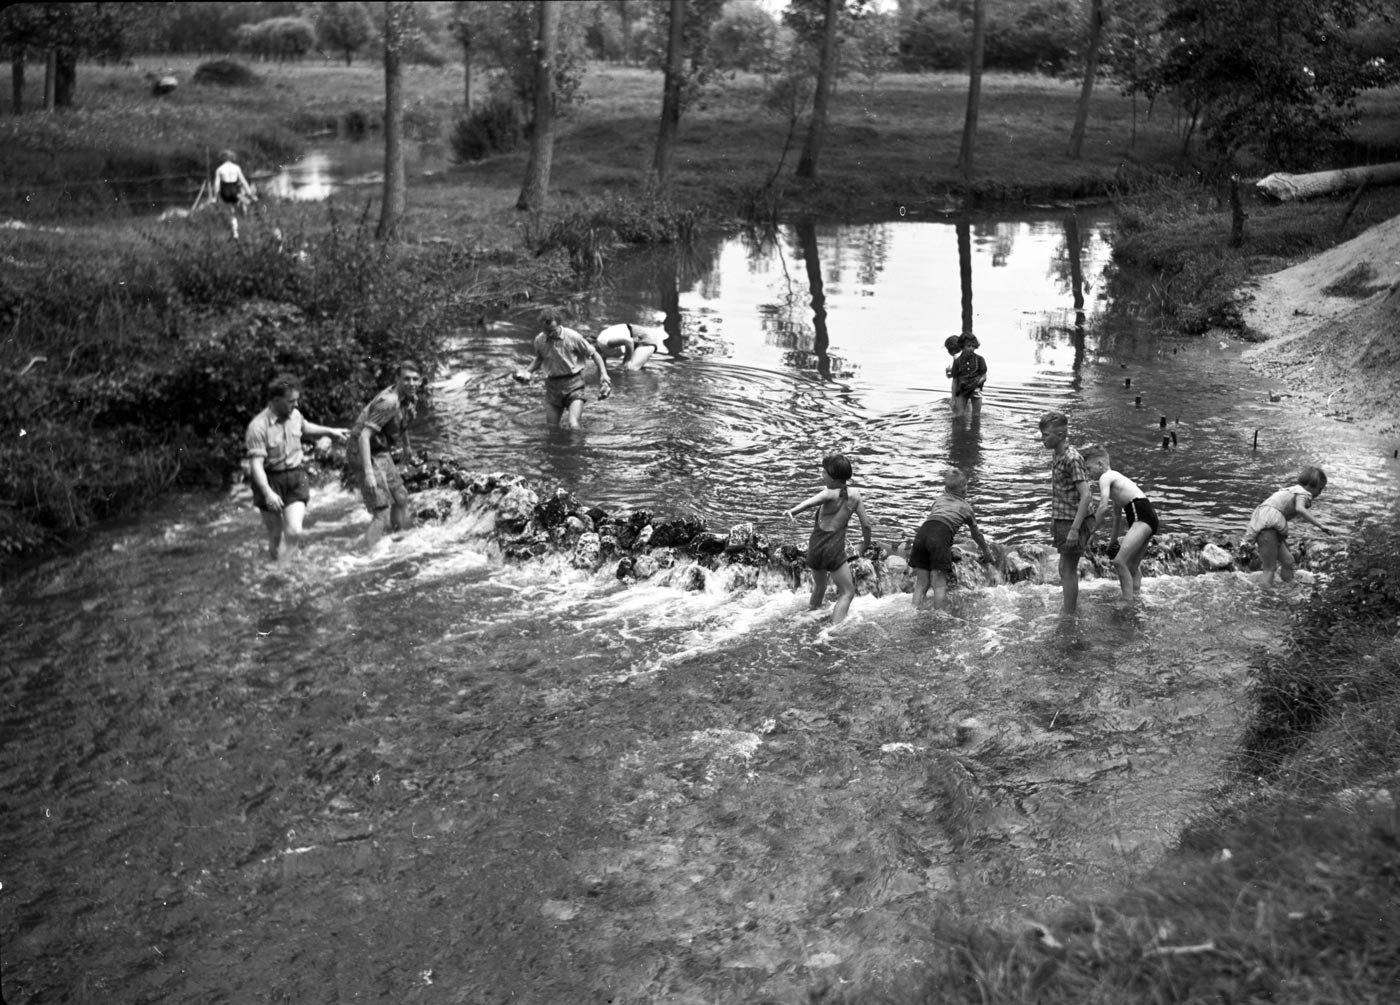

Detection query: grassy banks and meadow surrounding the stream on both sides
(0, 53), (1400, 1005)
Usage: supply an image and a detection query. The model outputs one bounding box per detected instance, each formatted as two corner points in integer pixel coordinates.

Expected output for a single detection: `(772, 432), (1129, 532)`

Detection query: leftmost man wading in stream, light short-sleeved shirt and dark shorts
(245, 374), (347, 561)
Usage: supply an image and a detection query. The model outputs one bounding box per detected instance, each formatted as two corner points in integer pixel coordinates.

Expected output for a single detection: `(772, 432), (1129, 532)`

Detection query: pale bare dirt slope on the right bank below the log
(1242, 217), (1400, 435)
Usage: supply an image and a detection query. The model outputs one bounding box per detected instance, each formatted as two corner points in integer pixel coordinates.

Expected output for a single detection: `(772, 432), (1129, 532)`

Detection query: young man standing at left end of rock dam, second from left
(346, 360), (423, 547)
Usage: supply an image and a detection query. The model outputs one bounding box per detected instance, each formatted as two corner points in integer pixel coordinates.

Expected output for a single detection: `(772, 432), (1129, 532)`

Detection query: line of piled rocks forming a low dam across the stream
(405, 458), (1336, 596)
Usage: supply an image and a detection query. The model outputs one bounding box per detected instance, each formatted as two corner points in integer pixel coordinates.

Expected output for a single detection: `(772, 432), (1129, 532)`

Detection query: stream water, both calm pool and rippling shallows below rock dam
(0, 218), (1397, 1002)
